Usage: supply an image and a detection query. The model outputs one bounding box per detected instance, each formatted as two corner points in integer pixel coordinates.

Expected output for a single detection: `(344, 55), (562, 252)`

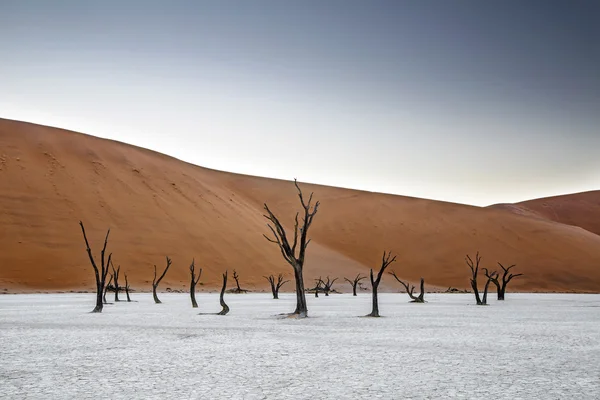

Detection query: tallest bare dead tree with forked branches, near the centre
(263, 179), (319, 318)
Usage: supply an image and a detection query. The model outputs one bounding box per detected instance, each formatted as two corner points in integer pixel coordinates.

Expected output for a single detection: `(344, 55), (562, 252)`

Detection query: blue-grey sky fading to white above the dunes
(0, 0), (600, 205)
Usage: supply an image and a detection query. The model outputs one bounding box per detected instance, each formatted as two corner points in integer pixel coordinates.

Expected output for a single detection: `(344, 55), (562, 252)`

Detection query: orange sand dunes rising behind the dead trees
(0, 119), (600, 292)
